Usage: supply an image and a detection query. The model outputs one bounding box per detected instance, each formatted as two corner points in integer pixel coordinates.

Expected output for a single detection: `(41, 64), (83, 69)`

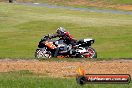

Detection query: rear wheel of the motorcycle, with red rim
(83, 47), (97, 58)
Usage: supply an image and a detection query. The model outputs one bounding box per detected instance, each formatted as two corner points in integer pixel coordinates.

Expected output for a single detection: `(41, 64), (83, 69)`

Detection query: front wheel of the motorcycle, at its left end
(35, 49), (52, 59)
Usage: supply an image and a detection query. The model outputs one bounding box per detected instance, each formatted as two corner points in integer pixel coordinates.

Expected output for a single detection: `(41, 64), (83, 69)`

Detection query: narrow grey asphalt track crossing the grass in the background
(16, 2), (132, 15)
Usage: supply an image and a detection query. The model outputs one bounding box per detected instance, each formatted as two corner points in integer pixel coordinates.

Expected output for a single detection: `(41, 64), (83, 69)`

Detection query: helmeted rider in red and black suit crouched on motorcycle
(51, 27), (77, 46)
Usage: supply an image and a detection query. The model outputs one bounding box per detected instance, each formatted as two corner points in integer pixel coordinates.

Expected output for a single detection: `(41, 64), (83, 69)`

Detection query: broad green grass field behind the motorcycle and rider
(0, 3), (132, 58)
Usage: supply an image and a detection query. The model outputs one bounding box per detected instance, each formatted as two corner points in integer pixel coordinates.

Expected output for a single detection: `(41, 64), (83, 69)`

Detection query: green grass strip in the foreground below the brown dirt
(0, 70), (132, 88)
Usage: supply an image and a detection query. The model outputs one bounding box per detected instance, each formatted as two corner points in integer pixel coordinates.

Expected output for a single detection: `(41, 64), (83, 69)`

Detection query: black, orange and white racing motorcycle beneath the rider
(35, 34), (97, 59)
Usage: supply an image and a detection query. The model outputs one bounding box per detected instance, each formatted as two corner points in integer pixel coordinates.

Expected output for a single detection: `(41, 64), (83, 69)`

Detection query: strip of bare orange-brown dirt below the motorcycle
(0, 59), (132, 77)
